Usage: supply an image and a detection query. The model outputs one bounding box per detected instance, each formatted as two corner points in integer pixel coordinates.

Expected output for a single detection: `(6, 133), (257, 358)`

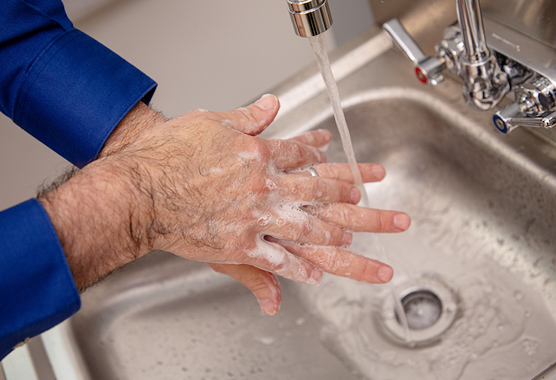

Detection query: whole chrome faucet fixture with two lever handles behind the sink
(383, 0), (556, 133)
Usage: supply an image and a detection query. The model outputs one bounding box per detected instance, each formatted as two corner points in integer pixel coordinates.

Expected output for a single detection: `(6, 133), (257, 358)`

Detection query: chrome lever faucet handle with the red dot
(383, 18), (445, 86)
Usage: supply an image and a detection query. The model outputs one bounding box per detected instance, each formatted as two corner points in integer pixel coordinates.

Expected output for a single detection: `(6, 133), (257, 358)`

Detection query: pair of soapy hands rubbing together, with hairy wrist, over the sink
(41, 96), (409, 314)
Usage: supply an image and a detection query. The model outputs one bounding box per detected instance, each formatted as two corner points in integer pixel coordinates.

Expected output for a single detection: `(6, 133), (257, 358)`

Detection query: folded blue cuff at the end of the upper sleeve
(13, 28), (156, 166)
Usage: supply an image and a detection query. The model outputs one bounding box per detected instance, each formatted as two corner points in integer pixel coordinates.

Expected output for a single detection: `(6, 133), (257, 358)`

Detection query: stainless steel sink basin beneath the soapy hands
(13, 32), (556, 380)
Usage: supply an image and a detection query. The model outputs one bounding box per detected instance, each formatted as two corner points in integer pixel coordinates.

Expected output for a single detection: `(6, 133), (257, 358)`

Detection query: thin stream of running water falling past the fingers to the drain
(309, 35), (412, 345)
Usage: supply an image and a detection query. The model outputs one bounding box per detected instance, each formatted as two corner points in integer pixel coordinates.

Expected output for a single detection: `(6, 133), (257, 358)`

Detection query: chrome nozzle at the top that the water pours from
(288, 0), (332, 37)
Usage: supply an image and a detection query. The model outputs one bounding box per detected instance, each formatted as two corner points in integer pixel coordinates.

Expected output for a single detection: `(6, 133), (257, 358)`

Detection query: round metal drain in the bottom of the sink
(381, 276), (457, 344)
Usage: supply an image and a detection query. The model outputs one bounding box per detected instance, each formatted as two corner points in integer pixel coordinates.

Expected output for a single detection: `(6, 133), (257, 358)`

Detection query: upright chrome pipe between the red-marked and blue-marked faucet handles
(456, 0), (510, 110)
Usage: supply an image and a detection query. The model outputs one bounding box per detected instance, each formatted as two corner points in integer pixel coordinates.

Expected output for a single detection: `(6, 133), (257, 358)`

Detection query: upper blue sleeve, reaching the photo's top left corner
(0, 0), (156, 166)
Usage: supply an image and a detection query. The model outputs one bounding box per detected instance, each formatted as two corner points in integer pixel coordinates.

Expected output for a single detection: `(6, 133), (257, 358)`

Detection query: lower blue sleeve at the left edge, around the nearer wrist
(0, 199), (80, 359)
